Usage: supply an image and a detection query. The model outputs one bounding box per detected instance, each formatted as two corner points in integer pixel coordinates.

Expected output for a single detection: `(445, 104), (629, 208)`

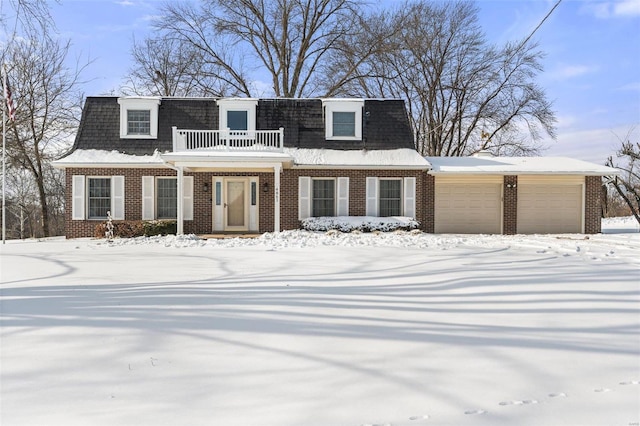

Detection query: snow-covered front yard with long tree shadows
(0, 219), (640, 426)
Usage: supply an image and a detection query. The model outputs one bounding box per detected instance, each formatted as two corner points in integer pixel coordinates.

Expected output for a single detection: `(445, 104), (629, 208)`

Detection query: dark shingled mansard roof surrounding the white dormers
(73, 97), (414, 155)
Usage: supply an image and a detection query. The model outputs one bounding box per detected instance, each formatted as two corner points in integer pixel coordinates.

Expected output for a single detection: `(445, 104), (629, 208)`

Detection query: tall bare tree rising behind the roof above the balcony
(146, 0), (361, 97)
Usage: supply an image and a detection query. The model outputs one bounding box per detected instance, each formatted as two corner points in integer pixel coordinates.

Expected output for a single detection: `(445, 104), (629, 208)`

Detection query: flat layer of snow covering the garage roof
(425, 156), (618, 176)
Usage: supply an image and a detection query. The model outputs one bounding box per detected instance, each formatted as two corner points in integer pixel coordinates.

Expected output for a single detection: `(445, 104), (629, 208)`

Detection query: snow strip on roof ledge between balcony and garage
(284, 148), (429, 170)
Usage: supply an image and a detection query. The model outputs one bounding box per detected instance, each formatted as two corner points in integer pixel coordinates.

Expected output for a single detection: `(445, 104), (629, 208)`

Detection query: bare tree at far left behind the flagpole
(5, 34), (84, 236)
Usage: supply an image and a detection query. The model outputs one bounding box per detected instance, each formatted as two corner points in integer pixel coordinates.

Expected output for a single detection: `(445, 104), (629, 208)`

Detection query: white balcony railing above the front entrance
(173, 127), (284, 152)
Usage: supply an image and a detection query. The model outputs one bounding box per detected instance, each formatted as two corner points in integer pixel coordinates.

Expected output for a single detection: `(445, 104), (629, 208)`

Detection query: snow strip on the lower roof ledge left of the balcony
(53, 149), (163, 167)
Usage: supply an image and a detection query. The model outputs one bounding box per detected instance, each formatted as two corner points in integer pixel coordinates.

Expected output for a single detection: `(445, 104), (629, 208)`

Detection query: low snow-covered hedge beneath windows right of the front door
(300, 216), (420, 232)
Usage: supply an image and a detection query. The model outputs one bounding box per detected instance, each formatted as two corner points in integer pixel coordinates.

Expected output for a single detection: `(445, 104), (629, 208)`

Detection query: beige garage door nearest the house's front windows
(435, 176), (503, 234)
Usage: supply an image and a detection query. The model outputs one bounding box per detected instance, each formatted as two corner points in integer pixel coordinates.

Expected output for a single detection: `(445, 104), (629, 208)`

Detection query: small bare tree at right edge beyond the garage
(606, 131), (640, 223)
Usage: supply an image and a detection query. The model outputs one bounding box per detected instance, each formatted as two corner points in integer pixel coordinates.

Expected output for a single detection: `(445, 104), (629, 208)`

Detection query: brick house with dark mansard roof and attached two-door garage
(54, 97), (616, 238)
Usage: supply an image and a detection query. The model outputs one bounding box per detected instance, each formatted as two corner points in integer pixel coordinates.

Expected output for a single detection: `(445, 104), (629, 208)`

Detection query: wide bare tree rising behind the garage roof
(333, 1), (555, 156)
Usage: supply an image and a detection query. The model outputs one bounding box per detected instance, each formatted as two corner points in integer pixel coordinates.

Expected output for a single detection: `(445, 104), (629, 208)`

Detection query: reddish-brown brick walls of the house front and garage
(65, 168), (601, 238)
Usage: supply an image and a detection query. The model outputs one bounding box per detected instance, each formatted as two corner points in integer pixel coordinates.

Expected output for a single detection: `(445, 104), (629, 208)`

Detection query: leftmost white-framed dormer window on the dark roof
(118, 97), (160, 139)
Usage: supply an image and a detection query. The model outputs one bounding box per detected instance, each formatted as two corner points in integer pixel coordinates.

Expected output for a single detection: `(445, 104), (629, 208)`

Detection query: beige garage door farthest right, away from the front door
(517, 176), (584, 234)
